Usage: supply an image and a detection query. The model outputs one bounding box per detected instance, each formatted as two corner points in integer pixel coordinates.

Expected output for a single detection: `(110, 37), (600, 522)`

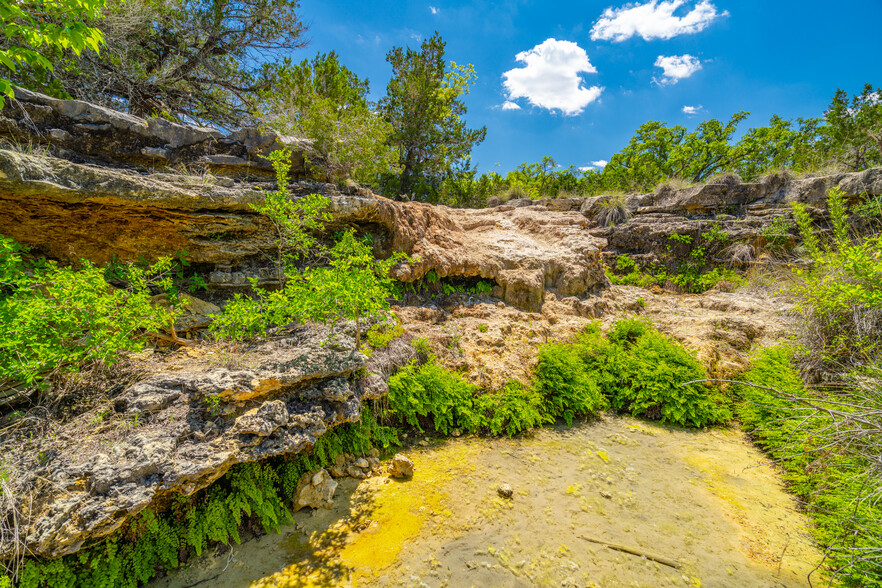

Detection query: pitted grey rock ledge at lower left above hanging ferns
(0, 327), (406, 557)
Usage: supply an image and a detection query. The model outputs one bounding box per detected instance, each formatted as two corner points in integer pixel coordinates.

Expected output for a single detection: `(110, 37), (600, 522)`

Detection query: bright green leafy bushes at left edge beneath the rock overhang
(0, 236), (174, 386)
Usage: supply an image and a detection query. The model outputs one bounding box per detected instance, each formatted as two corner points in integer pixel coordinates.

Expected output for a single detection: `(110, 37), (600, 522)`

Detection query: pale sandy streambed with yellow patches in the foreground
(153, 418), (821, 588)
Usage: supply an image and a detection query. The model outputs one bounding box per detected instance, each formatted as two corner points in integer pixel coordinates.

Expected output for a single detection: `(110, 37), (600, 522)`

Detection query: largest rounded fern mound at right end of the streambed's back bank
(610, 331), (732, 427)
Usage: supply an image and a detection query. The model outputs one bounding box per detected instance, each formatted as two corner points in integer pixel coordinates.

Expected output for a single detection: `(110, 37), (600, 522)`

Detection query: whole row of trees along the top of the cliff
(0, 0), (882, 206)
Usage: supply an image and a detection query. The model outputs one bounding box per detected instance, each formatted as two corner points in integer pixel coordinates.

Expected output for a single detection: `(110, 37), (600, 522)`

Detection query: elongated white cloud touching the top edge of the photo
(591, 0), (729, 42)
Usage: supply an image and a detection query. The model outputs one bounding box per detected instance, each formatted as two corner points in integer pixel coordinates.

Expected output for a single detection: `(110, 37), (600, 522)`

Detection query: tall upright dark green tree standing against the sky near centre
(380, 32), (487, 199)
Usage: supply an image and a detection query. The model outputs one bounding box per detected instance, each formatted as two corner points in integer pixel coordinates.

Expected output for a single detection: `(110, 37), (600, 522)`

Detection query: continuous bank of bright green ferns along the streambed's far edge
(385, 320), (731, 436)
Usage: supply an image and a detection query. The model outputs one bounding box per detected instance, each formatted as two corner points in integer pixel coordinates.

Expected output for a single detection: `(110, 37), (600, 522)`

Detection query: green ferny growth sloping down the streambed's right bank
(737, 347), (882, 587)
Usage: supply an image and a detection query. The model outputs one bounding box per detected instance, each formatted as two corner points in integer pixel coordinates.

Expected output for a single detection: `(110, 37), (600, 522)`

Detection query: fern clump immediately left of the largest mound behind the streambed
(533, 343), (607, 425)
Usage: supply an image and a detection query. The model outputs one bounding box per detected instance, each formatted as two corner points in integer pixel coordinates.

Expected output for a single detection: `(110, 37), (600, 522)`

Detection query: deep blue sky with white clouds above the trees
(292, 0), (882, 174)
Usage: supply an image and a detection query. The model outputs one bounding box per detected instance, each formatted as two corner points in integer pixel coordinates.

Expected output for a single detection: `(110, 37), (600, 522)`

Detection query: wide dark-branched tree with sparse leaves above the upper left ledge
(16, 0), (305, 127)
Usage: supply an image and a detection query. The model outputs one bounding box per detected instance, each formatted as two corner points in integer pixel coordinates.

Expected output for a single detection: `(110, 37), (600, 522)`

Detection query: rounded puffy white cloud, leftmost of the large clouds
(502, 39), (603, 115)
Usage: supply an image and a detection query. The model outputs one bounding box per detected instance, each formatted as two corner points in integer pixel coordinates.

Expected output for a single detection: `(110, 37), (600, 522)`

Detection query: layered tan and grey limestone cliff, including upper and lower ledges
(0, 91), (882, 572)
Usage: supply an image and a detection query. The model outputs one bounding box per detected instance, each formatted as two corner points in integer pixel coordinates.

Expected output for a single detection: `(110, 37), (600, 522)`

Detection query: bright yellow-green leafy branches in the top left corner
(0, 0), (105, 108)
